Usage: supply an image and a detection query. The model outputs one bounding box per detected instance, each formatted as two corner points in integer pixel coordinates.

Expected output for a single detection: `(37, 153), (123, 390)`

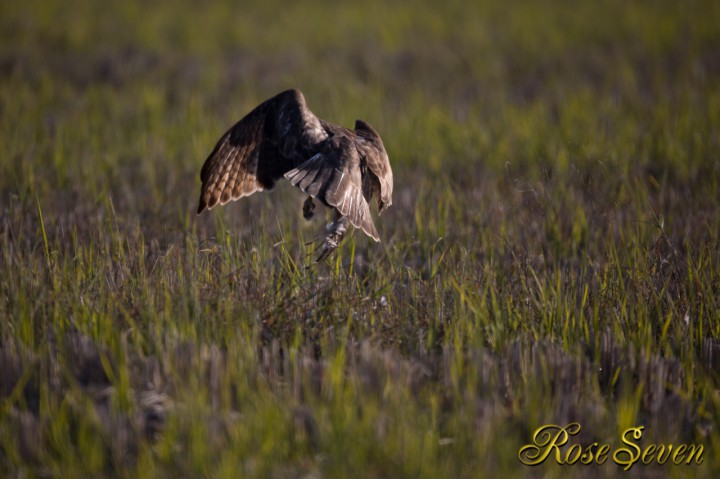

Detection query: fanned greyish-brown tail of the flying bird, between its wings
(285, 134), (380, 242)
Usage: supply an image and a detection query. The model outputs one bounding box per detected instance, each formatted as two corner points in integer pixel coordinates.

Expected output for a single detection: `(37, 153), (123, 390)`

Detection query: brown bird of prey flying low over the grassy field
(198, 90), (393, 261)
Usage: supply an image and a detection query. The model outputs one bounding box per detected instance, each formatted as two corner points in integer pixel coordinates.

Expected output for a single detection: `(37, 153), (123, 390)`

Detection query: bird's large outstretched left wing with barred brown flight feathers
(198, 90), (327, 214)
